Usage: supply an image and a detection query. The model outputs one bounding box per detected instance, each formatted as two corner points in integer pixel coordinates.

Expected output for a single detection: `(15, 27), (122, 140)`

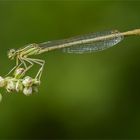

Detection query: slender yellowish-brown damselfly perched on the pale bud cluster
(7, 29), (140, 80)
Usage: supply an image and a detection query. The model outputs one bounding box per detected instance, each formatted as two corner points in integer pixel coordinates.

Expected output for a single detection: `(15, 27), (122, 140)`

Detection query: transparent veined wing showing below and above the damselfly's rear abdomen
(63, 31), (123, 53)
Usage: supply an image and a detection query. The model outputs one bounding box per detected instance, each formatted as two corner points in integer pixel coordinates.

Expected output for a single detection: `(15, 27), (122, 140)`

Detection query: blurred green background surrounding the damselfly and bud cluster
(0, 0), (140, 139)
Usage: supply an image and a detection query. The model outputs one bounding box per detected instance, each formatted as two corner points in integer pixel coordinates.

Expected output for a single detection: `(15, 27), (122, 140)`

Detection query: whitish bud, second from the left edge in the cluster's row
(6, 79), (16, 92)
